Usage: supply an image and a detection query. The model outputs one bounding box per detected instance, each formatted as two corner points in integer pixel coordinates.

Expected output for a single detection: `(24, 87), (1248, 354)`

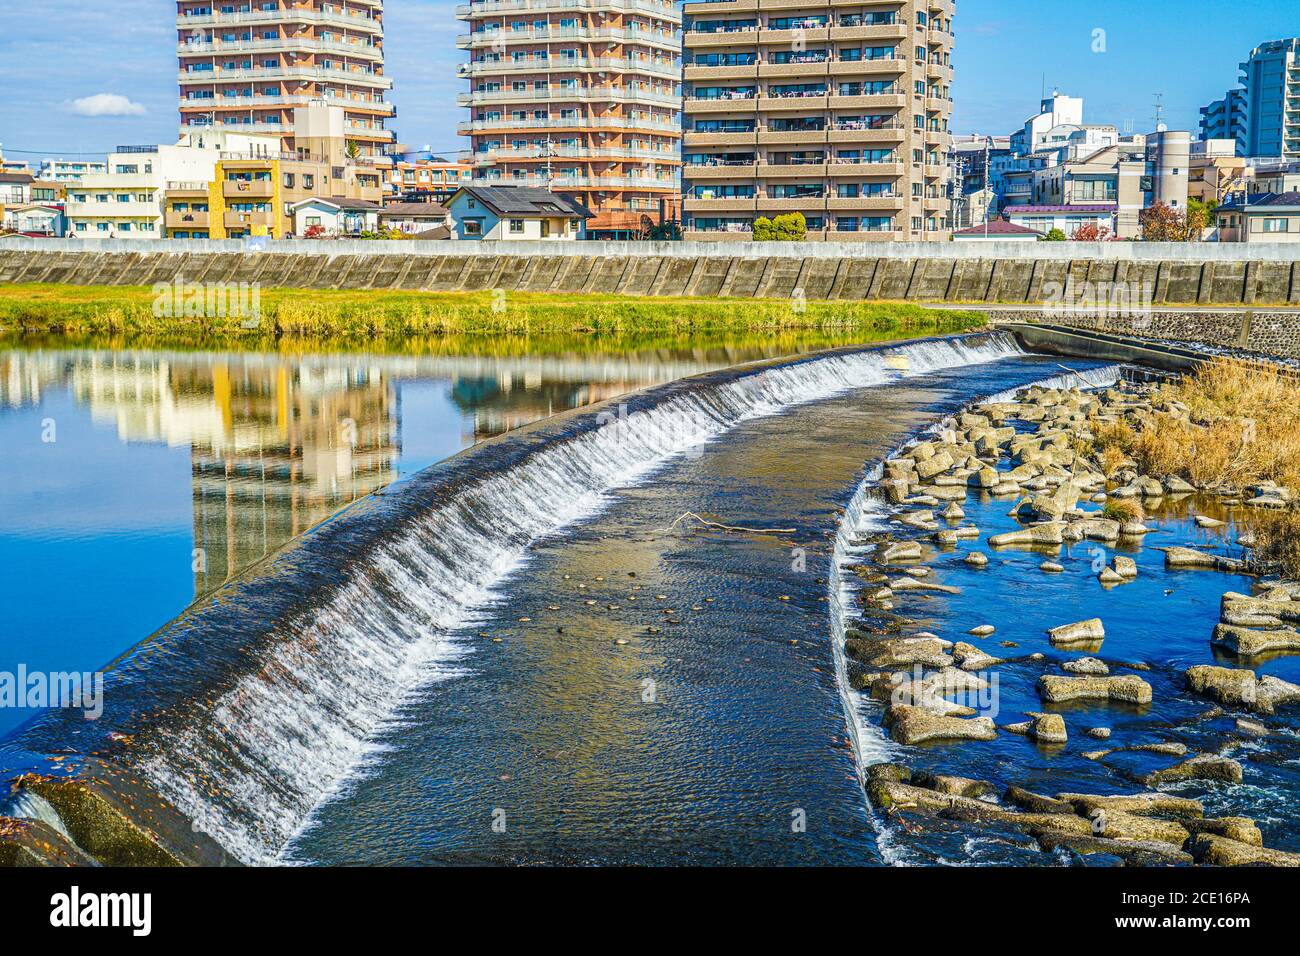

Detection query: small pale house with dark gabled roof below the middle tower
(447, 185), (594, 239)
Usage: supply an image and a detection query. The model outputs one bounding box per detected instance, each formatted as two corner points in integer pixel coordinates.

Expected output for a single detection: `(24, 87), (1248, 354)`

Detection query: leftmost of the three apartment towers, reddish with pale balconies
(176, 0), (395, 156)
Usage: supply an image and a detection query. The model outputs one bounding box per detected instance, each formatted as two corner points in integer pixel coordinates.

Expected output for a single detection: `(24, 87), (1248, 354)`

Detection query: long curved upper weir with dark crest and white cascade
(5, 334), (1019, 864)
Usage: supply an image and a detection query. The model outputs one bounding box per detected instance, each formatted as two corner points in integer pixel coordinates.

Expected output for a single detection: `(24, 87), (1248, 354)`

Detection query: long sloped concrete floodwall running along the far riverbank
(0, 239), (1300, 306)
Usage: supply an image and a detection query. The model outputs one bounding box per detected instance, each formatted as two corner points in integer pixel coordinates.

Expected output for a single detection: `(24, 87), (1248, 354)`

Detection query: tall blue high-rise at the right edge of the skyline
(1238, 38), (1300, 159)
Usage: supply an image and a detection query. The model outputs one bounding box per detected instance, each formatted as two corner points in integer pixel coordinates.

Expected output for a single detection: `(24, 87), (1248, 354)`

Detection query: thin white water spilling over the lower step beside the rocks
(828, 365), (1119, 865)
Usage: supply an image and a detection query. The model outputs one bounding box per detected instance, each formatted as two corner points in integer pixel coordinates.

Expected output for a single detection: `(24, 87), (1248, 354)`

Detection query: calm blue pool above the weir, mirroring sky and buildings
(0, 333), (904, 732)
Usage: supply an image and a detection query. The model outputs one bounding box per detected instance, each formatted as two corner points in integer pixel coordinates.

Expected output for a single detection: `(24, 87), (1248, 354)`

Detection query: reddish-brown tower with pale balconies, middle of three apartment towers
(456, 0), (681, 238)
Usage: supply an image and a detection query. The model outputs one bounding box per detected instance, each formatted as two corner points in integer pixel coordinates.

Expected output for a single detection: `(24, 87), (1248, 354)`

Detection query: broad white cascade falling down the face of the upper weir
(131, 336), (1021, 864)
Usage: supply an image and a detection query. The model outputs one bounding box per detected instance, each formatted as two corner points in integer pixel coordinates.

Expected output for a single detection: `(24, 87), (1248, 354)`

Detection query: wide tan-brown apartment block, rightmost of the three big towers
(683, 0), (954, 241)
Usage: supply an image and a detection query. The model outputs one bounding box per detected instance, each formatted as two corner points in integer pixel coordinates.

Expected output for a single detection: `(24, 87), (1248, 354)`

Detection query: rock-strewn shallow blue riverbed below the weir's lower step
(844, 371), (1300, 866)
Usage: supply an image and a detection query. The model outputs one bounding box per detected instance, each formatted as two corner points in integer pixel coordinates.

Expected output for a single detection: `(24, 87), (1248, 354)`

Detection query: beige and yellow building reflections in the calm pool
(0, 350), (733, 606)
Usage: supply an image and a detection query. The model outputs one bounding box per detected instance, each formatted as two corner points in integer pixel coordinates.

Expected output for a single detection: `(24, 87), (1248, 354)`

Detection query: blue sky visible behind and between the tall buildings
(0, 0), (1300, 159)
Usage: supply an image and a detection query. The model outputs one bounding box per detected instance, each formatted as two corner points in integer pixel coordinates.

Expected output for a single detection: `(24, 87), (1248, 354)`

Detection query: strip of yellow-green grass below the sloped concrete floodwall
(0, 285), (984, 342)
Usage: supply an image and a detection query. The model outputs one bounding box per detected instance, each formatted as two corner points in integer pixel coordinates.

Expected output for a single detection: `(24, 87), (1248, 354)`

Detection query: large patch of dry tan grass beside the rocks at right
(1097, 359), (1300, 488)
